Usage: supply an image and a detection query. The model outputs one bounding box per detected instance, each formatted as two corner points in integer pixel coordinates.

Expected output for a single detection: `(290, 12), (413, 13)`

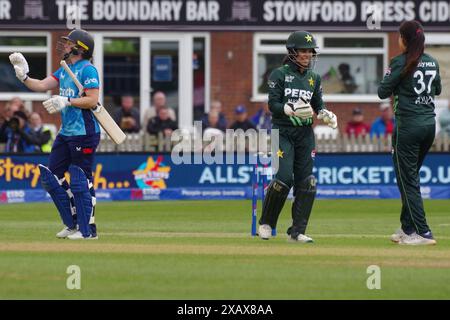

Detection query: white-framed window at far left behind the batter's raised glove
(0, 33), (51, 100)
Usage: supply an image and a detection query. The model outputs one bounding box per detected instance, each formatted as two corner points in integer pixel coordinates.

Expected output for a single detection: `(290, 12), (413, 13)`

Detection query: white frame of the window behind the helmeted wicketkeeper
(251, 32), (388, 103)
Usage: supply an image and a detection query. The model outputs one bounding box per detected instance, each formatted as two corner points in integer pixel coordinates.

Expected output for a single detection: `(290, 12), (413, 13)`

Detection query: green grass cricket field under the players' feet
(0, 200), (450, 300)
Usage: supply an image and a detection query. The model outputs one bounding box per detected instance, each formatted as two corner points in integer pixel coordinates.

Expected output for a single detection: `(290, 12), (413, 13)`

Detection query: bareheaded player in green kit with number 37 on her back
(378, 21), (442, 245)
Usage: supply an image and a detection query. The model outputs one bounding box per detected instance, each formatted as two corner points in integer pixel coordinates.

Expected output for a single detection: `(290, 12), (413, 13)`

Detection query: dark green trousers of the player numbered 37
(392, 125), (435, 234)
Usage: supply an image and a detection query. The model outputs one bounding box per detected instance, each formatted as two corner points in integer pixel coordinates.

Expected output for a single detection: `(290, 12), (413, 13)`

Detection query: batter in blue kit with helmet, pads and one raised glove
(9, 29), (100, 240)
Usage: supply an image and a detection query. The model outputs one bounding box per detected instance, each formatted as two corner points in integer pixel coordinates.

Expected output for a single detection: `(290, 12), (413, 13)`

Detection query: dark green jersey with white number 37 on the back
(378, 53), (442, 126)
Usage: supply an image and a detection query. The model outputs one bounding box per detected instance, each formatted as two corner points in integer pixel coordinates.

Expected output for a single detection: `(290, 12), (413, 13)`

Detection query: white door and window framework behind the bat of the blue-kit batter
(92, 31), (211, 128)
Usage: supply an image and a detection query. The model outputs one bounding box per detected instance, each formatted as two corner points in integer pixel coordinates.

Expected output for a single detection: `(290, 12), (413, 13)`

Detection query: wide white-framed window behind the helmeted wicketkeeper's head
(253, 33), (387, 102)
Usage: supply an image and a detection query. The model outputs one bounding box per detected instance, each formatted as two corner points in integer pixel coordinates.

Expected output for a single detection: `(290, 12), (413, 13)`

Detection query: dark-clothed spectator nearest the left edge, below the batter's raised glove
(0, 111), (35, 153)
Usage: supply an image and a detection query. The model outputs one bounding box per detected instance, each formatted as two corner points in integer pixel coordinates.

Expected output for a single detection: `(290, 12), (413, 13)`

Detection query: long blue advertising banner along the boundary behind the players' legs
(0, 153), (450, 203)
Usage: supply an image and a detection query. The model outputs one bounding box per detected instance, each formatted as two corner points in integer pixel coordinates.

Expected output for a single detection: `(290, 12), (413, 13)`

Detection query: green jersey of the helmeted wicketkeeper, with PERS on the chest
(267, 61), (325, 127)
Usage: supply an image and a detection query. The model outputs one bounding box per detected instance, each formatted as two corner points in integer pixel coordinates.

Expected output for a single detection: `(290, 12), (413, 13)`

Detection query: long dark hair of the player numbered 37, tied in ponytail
(399, 20), (425, 77)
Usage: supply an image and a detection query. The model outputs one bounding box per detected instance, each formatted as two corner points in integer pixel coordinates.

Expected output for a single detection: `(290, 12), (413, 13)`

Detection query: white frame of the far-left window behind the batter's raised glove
(0, 31), (52, 101)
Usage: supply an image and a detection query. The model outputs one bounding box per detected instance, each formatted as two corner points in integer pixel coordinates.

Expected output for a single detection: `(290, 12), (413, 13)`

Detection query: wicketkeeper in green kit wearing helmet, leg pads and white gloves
(258, 31), (337, 243)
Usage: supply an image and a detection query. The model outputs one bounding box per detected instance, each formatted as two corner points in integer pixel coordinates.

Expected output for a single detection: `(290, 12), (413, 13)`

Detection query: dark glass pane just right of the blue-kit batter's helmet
(103, 37), (140, 113)
